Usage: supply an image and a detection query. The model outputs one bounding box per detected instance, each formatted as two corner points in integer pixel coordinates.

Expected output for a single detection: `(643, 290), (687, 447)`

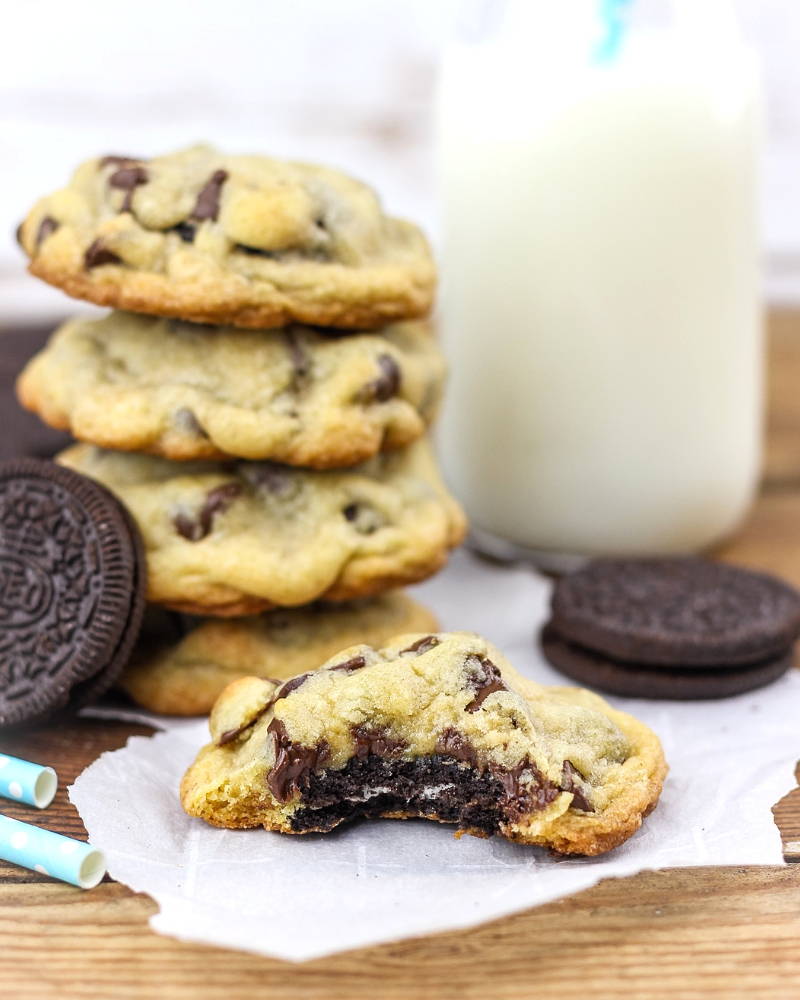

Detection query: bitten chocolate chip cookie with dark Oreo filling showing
(181, 632), (667, 855)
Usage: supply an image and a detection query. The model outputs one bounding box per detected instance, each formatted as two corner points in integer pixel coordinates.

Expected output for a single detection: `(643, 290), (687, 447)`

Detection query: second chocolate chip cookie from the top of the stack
(17, 312), (445, 468)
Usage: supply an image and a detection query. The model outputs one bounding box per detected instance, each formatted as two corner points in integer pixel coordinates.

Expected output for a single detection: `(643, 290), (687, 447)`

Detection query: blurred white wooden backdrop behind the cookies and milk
(0, 0), (800, 326)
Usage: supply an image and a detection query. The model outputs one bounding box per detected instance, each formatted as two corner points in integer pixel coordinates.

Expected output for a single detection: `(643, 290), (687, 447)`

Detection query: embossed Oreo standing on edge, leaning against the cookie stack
(0, 458), (146, 727)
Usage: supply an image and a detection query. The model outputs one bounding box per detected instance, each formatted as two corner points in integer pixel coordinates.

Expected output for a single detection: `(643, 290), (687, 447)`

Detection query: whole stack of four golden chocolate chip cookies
(18, 146), (465, 714)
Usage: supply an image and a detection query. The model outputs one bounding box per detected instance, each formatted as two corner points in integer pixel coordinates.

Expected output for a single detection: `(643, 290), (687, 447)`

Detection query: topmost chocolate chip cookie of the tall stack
(18, 146), (436, 329)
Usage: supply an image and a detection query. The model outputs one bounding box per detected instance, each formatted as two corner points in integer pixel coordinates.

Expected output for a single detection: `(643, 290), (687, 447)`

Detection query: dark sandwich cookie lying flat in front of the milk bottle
(541, 559), (800, 700)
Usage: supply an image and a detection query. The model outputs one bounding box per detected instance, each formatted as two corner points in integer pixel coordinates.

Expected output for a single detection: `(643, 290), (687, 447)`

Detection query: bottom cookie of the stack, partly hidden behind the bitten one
(117, 591), (438, 715)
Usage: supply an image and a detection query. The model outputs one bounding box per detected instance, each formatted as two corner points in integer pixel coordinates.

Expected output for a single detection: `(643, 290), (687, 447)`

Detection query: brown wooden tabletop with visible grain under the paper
(0, 313), (800, 1000)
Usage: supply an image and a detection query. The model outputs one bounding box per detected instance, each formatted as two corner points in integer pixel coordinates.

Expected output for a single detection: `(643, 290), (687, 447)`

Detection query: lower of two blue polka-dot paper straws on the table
(0, 815), (106, 889)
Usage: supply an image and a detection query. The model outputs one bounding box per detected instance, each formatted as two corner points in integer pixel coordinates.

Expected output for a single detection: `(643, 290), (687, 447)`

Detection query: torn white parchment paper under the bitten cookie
(70, 552), (800, 961)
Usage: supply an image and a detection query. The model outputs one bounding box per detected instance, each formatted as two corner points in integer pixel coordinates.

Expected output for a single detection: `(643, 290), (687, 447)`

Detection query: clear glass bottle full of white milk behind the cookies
(438, 0), (762, 568)
